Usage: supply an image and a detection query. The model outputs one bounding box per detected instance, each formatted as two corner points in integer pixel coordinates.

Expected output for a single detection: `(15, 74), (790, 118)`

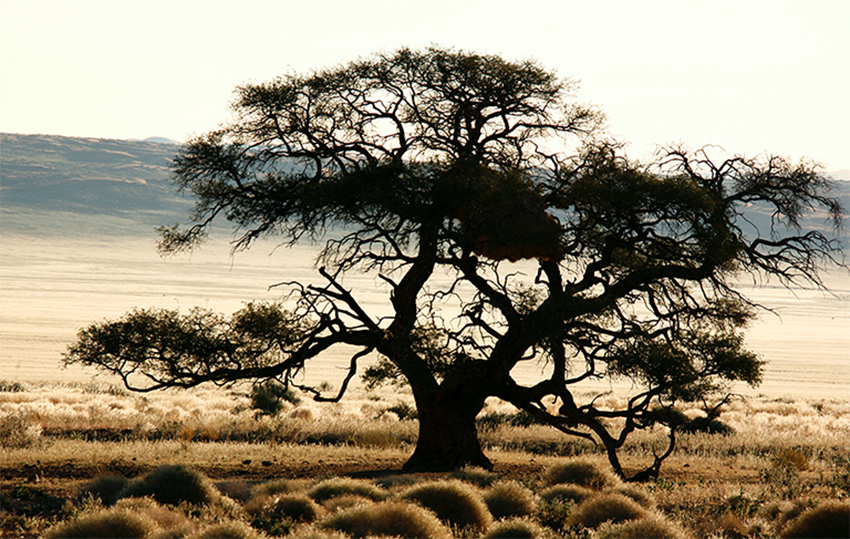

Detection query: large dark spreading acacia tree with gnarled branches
(66, 48), (842, 479)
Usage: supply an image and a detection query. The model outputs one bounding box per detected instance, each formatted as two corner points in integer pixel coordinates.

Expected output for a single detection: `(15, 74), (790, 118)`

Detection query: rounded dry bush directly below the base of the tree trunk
(400, 481), (493, 530)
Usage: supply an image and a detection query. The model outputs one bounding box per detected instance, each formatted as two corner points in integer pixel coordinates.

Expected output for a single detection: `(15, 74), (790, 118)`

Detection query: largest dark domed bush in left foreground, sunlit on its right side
(119, 465), (221, 505)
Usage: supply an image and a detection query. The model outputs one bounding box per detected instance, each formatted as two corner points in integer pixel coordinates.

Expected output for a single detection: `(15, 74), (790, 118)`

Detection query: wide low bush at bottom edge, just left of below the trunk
(318, 502), (452, 539)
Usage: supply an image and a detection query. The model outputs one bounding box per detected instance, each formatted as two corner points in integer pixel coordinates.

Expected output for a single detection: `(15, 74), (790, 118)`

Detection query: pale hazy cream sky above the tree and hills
(0, 0), (850, 170)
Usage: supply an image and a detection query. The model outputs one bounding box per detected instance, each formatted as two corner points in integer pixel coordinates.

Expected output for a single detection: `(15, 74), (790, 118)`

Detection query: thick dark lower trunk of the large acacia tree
(404, 369), (493, 472)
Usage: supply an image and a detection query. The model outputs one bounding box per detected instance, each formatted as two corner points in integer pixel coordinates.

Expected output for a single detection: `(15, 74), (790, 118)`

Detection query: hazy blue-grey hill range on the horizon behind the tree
(0, 133), (850, 236)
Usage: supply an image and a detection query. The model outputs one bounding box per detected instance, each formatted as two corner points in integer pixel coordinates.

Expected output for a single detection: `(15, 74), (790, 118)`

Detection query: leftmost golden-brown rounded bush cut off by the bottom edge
(45, 508), (157, 539)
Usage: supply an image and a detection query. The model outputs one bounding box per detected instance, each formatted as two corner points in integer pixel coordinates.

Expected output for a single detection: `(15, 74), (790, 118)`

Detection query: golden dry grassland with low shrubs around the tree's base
(0, 382), (850, 538)
